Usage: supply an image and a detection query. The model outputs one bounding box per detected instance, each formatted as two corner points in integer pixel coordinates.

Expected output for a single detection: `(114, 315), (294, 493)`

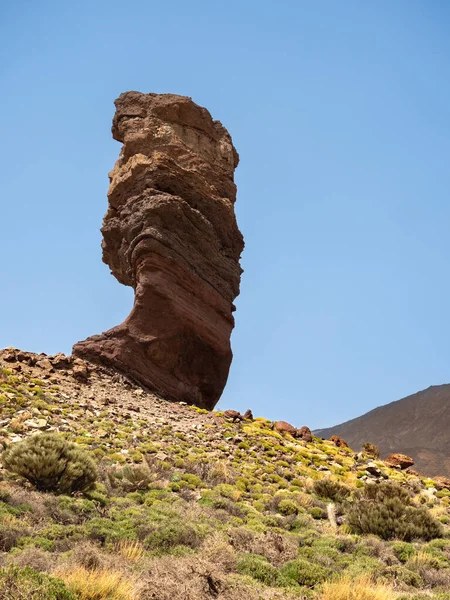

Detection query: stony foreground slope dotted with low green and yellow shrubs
(0, 349), (450, 600)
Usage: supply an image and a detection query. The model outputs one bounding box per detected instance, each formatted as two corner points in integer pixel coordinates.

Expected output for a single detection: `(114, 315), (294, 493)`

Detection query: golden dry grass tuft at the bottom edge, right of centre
(318, 577), (395, 600)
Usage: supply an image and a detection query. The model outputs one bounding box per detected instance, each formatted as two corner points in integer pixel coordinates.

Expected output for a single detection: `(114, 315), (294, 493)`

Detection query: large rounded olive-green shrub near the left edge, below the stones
(2, 433), (97, 494)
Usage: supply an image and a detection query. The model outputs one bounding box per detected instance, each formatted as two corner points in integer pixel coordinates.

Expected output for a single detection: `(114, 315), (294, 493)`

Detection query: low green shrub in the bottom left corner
(0, 566), (76, 600)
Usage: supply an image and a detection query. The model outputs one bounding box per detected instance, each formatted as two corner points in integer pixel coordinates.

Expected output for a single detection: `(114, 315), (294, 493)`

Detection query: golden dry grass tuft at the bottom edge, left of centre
(56, 567), (136, 600)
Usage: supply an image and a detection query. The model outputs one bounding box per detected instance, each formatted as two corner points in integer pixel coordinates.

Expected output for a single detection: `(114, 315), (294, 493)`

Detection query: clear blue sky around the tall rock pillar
(0, 0), (450, 427)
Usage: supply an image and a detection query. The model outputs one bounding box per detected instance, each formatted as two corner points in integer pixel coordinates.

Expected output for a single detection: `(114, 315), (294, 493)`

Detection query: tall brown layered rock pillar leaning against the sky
(73, 92), (244, 409)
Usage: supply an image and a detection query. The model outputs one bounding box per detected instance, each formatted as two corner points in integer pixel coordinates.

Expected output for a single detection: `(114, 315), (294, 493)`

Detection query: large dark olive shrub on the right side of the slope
(347, 482), (442, 542)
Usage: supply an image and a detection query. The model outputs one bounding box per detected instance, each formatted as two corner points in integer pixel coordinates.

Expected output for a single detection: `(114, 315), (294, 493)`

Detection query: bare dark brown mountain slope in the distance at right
(315, 384), (450, 477)
